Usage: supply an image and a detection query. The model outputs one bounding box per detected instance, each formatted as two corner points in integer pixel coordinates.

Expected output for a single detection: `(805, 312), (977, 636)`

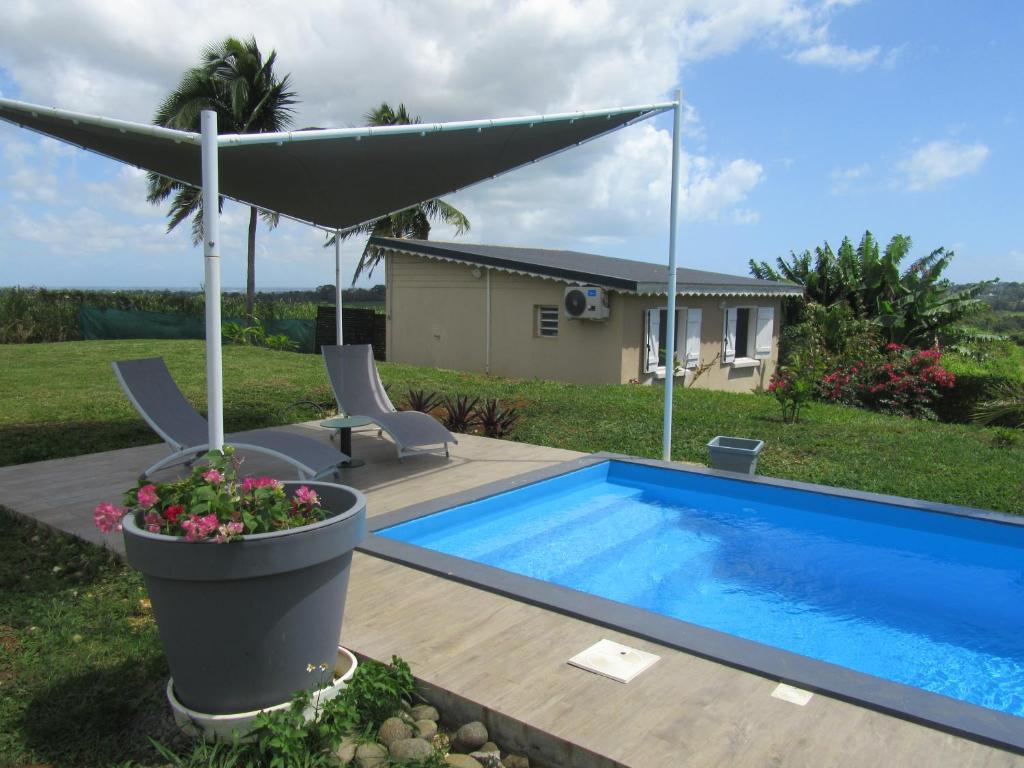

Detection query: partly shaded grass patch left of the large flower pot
(0, 508), (174, 768)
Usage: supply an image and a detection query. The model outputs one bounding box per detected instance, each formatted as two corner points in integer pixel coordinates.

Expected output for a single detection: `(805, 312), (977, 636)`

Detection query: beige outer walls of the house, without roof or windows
(385, 252), (780, 391)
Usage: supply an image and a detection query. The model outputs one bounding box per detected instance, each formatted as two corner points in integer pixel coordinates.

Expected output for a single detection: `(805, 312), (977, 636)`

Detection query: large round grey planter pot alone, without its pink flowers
(124, 482), (367, 715)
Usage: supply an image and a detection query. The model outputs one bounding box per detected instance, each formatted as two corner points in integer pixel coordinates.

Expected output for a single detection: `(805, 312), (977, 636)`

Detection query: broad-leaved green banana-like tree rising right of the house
(750, 231), (989, 346)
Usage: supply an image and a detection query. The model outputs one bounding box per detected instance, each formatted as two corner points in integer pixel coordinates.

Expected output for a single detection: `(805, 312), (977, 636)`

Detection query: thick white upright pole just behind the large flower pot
(201, 110), (224, 449)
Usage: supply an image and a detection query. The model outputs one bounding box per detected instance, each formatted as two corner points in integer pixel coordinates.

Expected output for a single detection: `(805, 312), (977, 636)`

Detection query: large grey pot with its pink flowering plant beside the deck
(93, 446), (366, 715)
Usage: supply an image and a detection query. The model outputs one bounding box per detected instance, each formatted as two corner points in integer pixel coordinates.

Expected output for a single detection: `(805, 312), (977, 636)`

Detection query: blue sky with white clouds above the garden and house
(0, 0), (1024, 289)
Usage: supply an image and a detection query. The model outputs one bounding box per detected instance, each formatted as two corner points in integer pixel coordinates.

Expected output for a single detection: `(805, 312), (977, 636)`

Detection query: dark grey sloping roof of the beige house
(370, 238), (804, 296)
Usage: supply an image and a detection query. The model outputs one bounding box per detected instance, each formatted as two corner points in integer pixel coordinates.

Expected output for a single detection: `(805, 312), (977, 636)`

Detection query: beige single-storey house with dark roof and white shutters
(369, 238), (803, 392)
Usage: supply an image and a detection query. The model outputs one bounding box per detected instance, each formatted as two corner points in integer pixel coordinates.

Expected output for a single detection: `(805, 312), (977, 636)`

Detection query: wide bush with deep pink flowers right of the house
(818, 344), (955, 419)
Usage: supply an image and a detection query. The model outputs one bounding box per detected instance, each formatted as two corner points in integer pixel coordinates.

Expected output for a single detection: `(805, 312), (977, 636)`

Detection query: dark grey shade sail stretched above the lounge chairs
(0, 99), (674, 229)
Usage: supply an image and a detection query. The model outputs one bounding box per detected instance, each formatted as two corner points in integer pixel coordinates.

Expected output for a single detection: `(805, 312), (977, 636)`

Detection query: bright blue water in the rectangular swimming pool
(378, 461), (1024, 717)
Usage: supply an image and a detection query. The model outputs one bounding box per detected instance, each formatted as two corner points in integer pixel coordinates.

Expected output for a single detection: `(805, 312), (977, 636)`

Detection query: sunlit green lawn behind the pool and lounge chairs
(0, 341), (1024, 514)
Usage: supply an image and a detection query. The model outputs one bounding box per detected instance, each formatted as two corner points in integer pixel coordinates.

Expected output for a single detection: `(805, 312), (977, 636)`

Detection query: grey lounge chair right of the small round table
(322, 344), (459, 459)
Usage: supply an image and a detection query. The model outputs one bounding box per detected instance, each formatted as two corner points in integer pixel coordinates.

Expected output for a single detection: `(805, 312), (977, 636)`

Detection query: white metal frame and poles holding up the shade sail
(0, 90), (682, 460)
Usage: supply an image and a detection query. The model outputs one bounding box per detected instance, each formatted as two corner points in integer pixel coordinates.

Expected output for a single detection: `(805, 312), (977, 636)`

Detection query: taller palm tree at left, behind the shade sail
(146, 37), (297, 323)
